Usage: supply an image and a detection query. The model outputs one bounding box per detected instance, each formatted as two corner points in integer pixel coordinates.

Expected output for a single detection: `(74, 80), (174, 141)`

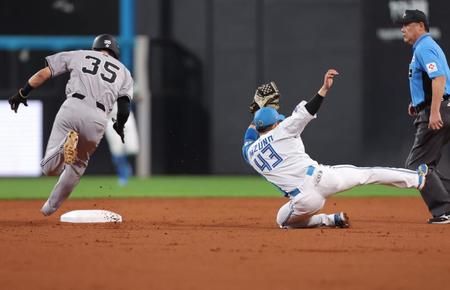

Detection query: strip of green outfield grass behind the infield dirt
(0, 176), (419, 199)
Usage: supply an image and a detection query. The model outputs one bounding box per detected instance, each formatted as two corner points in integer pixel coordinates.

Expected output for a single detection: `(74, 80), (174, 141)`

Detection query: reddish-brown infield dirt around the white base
(0, 197), (450, 290)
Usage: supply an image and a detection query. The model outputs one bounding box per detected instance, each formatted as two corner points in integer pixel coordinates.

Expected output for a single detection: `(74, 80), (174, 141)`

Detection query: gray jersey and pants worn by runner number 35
(41, 50), (133, 211)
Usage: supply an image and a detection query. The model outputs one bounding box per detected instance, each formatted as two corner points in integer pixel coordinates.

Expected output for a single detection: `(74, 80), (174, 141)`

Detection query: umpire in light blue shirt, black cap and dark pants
(398, 10), (450, 224)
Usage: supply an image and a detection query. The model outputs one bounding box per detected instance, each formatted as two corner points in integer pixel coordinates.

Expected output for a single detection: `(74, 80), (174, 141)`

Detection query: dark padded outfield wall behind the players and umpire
(0, 0), (450, 174)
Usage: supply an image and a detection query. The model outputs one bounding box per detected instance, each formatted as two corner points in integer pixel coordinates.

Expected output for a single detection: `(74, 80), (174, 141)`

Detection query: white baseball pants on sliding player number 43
(277, 165), (419, 228)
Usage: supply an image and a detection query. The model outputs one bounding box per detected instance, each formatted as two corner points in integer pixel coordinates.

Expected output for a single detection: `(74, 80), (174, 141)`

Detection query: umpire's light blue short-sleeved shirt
(409, 33), (450, 106)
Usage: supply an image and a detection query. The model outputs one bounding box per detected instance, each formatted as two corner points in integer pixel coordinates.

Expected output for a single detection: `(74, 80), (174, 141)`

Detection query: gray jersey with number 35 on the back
(46, 50), (133, 113)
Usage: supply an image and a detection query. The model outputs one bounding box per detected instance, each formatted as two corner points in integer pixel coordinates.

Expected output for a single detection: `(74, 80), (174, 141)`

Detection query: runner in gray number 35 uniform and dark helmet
(9, 34), (133, 216)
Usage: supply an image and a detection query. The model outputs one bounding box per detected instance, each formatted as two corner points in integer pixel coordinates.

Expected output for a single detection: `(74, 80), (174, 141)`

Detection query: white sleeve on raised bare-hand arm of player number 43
(279, 101), (317, 136)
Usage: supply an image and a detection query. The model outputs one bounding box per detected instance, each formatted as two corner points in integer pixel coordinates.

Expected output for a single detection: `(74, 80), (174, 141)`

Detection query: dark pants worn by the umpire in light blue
(406, 101), (450, 217)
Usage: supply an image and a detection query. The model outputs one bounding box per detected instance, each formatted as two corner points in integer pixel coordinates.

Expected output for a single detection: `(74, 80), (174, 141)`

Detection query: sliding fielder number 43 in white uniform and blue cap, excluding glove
(242, 69), (428, 228)
